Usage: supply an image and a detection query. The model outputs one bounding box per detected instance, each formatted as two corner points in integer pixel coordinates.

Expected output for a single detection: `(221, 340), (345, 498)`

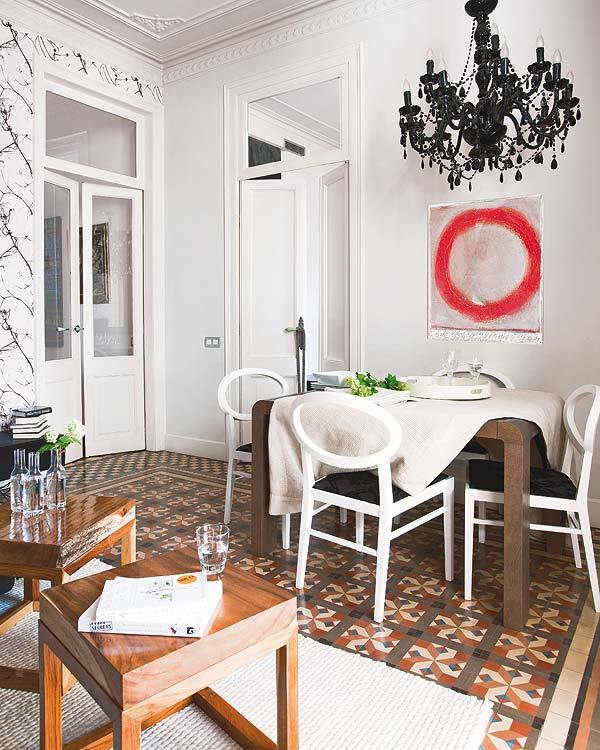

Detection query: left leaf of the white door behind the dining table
(240, 173), (307, 418)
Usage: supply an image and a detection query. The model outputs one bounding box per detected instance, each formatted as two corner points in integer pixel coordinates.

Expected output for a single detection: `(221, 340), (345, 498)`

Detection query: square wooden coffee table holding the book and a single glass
(39, 548), (298, 750)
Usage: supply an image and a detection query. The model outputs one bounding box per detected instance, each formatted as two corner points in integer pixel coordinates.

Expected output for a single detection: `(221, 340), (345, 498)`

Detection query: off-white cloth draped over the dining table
(269, 389), (563, 515)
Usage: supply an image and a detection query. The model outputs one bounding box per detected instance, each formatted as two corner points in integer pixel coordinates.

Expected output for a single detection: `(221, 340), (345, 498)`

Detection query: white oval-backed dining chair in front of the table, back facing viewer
(291, 393), (454, 622)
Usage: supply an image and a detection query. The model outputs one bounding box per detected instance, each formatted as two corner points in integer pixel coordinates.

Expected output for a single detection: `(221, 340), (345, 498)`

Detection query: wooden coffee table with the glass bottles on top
(0, 495), (135, 692)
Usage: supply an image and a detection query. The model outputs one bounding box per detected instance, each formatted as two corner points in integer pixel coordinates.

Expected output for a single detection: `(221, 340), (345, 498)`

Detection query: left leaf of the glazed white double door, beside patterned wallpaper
(42, 172), (82, 461)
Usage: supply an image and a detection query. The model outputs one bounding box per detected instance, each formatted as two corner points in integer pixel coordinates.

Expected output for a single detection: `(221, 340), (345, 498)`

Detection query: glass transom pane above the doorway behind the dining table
(247, 78), (341, 167)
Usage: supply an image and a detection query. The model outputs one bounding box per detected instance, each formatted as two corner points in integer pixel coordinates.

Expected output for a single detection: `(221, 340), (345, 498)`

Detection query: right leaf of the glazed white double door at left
(82, 184), (146, 456)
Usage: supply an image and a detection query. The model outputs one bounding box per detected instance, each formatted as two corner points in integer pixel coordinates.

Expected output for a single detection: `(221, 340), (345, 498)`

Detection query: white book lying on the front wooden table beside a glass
(78, 573), (223, 638)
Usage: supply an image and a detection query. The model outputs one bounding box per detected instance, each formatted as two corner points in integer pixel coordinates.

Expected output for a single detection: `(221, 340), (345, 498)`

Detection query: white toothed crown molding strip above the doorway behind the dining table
(163, 0), (424, 84)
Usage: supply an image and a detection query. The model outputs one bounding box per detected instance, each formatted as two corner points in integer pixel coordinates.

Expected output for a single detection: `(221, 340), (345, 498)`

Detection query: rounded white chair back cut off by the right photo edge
(562, 385), (600, 505)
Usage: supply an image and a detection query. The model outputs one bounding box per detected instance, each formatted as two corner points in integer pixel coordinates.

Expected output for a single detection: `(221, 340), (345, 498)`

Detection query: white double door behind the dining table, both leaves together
(240, 164), (349, 410)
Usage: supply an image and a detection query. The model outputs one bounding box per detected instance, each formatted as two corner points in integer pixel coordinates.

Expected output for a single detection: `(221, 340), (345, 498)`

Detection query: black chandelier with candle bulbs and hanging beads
(399, 0), (581, 190)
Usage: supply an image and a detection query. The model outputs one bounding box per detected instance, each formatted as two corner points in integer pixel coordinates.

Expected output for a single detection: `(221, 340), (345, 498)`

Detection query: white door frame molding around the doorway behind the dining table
(223, 44), (364, 388)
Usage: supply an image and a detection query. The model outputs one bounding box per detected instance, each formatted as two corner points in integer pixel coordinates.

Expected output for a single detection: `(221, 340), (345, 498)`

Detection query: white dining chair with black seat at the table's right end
(465, 385), (600, 612)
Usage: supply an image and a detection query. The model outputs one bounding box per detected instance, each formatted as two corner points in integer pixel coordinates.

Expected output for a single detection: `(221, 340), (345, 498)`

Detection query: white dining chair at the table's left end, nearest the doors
(217, 367), (290, 549)
